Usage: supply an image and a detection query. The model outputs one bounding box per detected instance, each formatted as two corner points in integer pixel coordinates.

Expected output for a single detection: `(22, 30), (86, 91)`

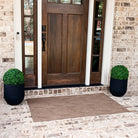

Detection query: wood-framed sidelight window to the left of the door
(22, 0), (37, 86)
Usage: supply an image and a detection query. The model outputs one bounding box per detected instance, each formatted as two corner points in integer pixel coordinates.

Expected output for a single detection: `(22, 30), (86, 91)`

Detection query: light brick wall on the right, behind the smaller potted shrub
(112, 0), (138, 93)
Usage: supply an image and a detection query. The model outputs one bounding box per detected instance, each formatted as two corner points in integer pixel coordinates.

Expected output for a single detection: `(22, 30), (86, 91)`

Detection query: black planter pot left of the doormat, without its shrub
(4, 84), (24, 105)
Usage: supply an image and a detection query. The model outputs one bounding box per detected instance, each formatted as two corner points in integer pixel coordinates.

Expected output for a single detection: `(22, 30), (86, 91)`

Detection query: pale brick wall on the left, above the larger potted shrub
(0, 0), (15, 93)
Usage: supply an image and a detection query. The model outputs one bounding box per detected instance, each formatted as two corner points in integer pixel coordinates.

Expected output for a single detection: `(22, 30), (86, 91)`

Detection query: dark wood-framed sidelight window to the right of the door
(91, 0), (106, 83)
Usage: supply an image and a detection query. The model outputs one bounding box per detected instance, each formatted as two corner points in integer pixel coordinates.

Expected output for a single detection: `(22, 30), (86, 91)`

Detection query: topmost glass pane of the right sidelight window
(95, 2), (103, 17)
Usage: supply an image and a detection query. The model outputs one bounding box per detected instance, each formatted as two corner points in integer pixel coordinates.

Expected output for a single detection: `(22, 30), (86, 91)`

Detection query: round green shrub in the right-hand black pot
(111, 65), (129, 80)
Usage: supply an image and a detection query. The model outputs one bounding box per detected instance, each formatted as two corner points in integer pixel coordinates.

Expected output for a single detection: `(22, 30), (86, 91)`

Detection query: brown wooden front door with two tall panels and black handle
(42, 0), (89, 86)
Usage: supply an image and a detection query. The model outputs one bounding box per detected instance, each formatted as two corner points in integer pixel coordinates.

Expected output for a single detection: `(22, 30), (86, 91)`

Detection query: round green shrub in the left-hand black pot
(3, 69), (24, 85)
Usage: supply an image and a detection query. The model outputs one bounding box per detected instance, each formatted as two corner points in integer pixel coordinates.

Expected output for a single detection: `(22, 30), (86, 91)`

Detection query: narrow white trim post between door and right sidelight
(85, 0), (94, 85)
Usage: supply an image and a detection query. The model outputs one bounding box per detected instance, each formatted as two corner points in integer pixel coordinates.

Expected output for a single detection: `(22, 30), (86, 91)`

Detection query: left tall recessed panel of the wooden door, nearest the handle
(47, 14), (63, 73)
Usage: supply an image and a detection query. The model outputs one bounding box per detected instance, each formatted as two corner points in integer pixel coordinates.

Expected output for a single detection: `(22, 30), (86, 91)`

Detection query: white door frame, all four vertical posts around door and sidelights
(14, 0), (115, 88)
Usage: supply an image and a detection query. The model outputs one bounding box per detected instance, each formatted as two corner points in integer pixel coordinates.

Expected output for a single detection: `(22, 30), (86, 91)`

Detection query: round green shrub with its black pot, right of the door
(110, 65), (129, 97)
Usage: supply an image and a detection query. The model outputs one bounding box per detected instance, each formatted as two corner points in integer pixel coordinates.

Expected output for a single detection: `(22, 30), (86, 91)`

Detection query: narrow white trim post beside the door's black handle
(37, 0), (42, 88)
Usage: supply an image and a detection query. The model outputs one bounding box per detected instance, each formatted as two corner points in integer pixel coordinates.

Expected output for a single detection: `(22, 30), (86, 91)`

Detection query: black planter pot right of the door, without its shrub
(110, 78), (128, 97)
